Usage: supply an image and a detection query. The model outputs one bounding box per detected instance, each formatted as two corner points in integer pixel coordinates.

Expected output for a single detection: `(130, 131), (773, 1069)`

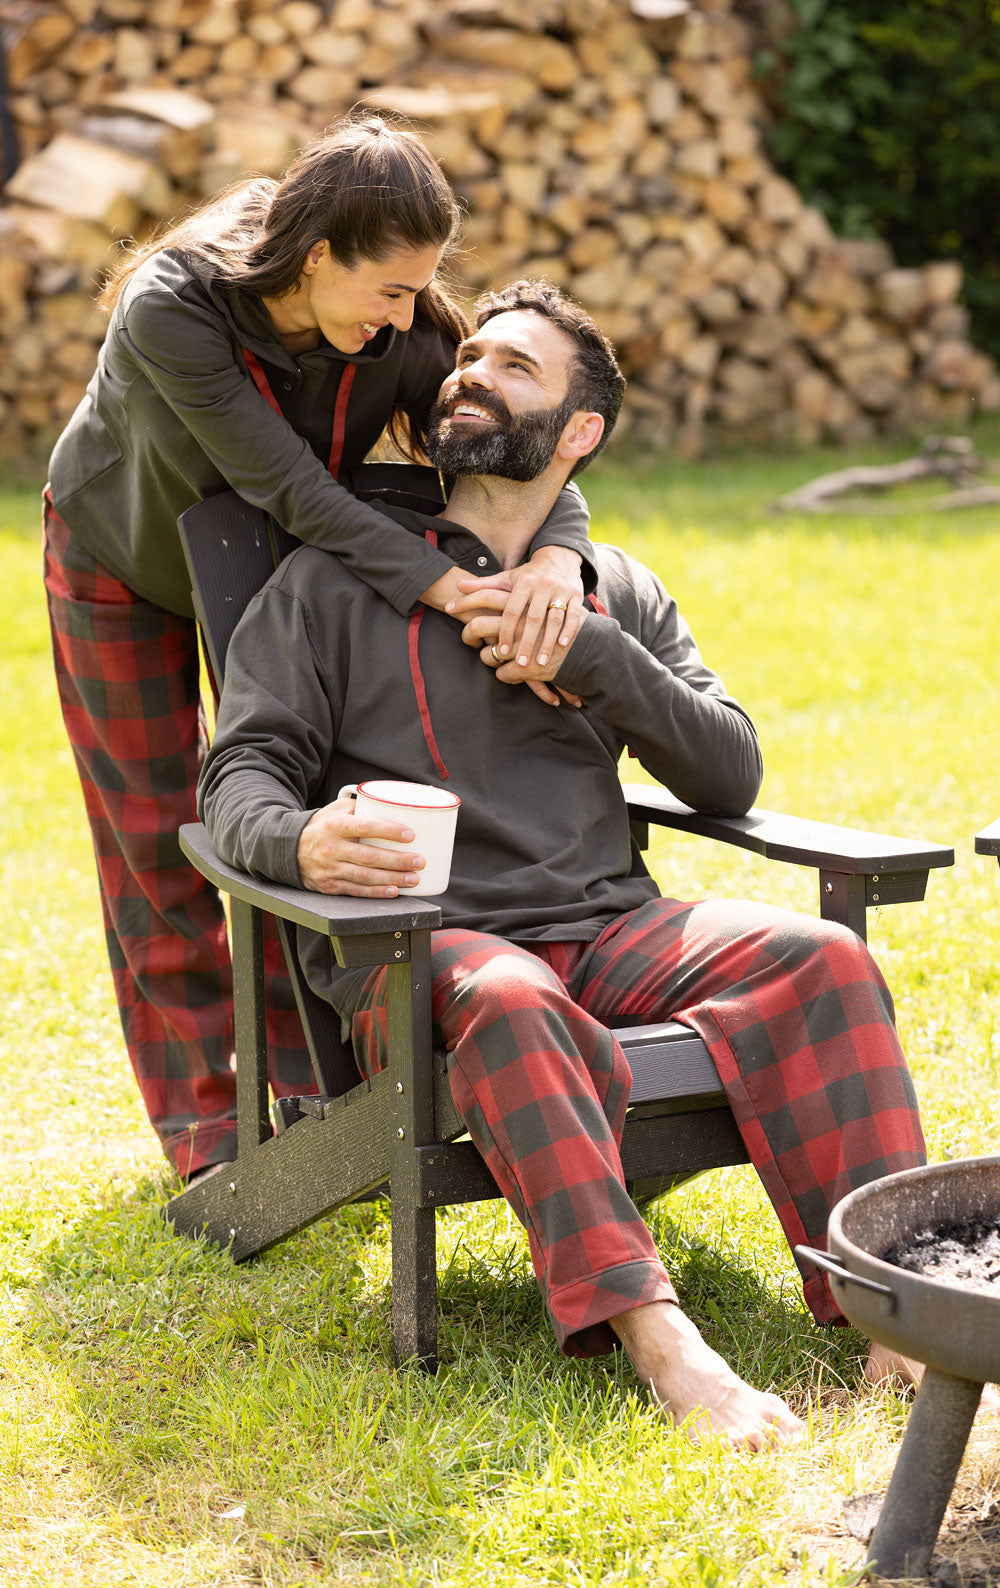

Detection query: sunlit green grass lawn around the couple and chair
(0, 424), (1000, 1588)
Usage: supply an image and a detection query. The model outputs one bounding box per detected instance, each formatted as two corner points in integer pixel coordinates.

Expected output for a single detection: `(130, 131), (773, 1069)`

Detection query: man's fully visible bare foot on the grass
(608, 1301), (805, 1450)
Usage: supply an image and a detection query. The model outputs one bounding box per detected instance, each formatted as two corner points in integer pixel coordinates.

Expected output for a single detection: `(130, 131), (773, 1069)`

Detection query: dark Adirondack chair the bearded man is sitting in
(167, 464), (954, 1367)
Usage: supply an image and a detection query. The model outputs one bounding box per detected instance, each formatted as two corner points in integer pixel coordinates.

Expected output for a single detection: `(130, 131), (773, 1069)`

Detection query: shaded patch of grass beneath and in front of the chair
(5, 1170), (895, 1582)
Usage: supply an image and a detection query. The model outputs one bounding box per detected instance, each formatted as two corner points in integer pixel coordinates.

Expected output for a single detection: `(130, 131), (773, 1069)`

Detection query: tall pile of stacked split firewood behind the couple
(0, 0), (1000, 456)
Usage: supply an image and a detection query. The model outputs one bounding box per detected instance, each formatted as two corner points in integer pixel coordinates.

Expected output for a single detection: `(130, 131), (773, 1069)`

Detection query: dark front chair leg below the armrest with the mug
(387, 931), (438, 1372)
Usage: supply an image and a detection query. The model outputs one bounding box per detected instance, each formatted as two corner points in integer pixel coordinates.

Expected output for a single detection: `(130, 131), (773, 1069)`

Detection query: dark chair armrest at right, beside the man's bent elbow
(624, 783), (958, 877)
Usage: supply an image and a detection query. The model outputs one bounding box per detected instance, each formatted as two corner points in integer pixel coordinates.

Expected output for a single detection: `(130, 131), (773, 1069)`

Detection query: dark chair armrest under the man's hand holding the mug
(178, 821), (441, 937)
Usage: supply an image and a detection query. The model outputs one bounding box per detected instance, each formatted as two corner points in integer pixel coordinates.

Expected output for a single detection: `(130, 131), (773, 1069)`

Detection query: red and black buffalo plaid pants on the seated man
(344, 899), (924, 1356)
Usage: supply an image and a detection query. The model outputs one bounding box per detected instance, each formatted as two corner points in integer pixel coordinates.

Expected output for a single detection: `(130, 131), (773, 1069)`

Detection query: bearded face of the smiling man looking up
(427, 310), (576, 481)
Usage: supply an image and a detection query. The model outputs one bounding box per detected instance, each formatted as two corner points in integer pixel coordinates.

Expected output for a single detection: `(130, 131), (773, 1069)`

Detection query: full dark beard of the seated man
(427, 386), (579, 483)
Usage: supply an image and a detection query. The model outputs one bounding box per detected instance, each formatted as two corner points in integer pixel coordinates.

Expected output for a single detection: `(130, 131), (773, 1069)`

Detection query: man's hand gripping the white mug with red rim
(295, 797), (424, 899)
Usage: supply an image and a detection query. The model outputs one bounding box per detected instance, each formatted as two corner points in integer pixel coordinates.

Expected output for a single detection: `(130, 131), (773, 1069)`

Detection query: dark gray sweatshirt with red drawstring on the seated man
(198, 508), (762, 1008)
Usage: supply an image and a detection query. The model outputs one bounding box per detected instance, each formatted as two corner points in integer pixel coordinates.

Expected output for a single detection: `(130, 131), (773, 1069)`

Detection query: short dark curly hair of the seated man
(475, 279), (625, 478)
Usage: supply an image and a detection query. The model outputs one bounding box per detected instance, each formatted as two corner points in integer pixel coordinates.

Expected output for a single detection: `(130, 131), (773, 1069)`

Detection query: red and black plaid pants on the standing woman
(44, 494), (316, 1175)
